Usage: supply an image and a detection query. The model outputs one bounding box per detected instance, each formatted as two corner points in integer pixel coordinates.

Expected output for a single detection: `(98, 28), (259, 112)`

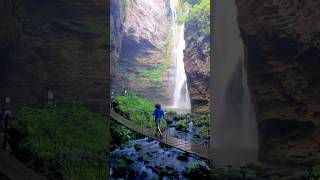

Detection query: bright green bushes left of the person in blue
(115, 94), (165, 128)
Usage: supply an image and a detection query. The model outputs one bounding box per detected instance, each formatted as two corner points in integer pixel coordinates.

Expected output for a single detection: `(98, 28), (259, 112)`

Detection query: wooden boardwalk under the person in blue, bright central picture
(110, 109), (209, 159)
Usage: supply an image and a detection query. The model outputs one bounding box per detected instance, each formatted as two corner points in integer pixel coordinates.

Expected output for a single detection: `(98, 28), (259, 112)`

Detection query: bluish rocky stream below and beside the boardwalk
(110, 114), (209, 180)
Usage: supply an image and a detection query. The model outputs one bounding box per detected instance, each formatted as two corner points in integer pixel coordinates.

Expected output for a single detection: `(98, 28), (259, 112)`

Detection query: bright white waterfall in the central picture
(170, 0), (191, 112)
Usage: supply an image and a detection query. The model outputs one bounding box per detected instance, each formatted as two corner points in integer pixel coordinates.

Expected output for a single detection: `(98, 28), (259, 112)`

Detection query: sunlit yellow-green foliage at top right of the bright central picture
(176, 0), (210, 37)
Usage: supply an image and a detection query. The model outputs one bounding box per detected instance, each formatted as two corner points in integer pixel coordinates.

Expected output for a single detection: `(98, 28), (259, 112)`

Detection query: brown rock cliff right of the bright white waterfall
(184, 21), (210, 112)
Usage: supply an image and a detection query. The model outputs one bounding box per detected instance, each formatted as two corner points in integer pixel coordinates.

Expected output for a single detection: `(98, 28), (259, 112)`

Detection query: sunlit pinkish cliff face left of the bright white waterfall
(111, 0), (173, 104)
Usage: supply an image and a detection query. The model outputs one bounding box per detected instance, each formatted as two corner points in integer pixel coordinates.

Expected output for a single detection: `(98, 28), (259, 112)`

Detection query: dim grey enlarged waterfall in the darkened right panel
(211, 0), (258, 164)
